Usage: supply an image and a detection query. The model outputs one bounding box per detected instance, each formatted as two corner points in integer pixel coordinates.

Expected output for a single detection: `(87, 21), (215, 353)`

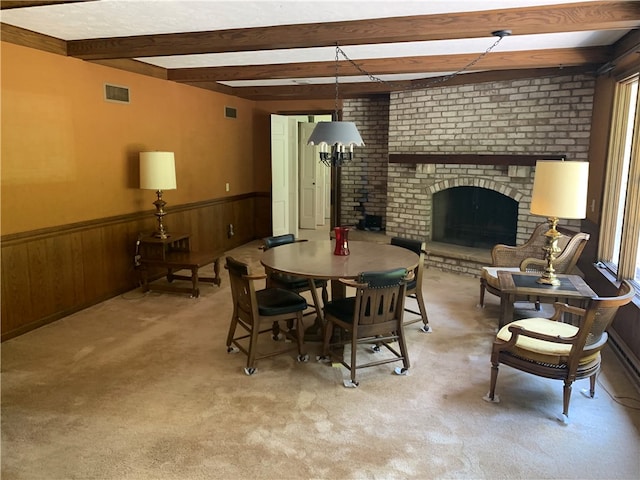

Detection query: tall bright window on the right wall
(598, 75), (640, 287)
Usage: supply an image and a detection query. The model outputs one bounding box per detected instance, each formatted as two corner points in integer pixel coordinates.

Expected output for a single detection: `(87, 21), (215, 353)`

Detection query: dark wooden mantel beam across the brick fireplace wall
(389, 157), (566, 167)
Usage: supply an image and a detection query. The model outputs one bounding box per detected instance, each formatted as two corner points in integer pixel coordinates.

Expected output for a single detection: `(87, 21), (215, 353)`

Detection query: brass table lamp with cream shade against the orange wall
(140, 152), (176, 239)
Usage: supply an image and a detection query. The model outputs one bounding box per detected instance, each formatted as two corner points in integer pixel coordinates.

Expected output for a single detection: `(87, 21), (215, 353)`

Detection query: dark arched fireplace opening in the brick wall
(431, 187), (518, 248)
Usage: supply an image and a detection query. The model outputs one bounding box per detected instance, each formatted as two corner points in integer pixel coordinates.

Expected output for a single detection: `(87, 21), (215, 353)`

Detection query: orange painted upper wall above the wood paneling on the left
(0, 42), (255, 235)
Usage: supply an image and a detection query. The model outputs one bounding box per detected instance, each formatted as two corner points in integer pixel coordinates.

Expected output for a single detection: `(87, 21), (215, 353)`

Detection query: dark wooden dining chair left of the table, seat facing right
(225, 257), (309, 375)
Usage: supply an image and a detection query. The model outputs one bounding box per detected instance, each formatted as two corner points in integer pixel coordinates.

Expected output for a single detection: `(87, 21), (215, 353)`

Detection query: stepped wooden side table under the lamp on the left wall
(139, 233), (223, 298)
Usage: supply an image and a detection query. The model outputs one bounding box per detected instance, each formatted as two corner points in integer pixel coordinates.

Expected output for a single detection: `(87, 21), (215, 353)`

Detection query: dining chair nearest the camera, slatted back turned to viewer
(318, 268), (412, 387)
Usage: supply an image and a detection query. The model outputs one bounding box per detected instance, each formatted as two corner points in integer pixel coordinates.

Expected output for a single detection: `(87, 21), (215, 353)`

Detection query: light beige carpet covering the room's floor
(1, 238), (640, 480)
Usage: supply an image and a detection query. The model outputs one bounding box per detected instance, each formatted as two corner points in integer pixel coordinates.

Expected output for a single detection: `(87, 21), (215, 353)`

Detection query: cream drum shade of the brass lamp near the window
(531, 160), (589, 219)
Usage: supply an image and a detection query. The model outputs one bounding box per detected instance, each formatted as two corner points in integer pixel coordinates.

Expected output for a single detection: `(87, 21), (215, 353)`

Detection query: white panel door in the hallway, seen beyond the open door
(299, 123), (318, 229)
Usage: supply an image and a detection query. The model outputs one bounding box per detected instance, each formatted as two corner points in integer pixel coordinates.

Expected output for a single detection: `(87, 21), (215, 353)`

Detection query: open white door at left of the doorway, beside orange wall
(271, 115), (291, 235)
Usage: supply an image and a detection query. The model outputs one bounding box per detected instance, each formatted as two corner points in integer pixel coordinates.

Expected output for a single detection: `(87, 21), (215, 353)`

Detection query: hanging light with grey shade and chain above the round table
(307, 45), (364, 167)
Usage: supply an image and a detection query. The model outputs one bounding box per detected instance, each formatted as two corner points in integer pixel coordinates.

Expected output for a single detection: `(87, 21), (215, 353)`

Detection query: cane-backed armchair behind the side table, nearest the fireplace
(479, 222), (590, 310)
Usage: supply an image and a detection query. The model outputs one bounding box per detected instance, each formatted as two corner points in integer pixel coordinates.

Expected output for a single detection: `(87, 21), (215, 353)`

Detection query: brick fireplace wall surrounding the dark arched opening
(341, 74), (595, 274)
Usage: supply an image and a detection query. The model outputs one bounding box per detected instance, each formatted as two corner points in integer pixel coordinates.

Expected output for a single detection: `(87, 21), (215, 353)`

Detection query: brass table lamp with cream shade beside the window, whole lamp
(531, 160), (589, 286)
